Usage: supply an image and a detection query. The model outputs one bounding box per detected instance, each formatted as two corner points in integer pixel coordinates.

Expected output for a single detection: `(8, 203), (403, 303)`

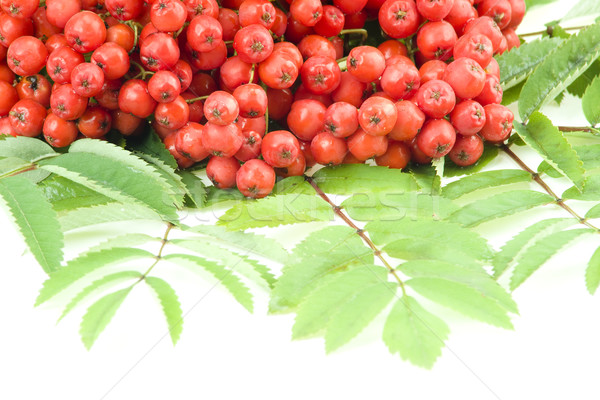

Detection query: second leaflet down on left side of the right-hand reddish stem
(448, 190), (554, 227)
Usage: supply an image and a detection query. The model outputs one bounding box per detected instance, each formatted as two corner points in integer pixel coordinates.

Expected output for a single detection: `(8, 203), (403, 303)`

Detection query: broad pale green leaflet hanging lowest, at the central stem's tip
(383, 296), (450, 369)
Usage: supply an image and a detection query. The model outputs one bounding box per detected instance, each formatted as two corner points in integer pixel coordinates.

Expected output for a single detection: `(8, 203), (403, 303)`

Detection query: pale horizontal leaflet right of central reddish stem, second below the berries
(341, 192), (457, 221)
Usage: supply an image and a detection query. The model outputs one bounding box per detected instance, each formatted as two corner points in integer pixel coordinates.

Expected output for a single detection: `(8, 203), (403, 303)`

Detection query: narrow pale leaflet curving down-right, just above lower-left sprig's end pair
(163, 254), (254, 312)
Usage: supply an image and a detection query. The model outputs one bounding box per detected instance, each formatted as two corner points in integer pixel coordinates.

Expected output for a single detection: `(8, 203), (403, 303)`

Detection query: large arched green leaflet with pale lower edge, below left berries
(40, 153), (178, 222)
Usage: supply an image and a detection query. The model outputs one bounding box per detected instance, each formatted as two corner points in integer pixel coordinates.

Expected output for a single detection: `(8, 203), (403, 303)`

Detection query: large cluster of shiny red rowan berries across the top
(0, 0), (525, 198)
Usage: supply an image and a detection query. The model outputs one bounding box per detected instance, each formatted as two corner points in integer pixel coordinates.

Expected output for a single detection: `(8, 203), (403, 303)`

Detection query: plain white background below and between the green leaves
(0, 1), (600, 400)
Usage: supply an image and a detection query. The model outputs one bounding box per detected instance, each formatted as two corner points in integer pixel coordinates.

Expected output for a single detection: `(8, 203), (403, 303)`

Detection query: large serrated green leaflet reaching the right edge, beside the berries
(519, 23), (600, 121)
